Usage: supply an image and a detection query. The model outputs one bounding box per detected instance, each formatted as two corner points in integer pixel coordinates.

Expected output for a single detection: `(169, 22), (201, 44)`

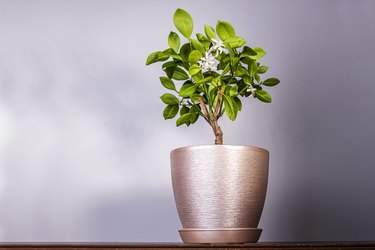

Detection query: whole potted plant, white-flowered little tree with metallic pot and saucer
(146, 9), (280, 243)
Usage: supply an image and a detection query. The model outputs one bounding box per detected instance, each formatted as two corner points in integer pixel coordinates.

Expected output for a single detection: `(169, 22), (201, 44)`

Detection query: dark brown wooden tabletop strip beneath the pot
(0, 241), (375, 250)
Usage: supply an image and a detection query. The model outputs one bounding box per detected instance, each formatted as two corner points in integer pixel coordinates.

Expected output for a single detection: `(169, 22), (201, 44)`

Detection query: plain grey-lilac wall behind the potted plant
(0, 0), (375, 242)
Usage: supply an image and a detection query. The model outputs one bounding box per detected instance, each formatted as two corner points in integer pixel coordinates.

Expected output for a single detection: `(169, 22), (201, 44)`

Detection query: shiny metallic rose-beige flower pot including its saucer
(171, 145), (269, 243)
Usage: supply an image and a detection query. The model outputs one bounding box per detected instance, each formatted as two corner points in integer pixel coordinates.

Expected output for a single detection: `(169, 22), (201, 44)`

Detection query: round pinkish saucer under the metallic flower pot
(179, 228), (262, 244)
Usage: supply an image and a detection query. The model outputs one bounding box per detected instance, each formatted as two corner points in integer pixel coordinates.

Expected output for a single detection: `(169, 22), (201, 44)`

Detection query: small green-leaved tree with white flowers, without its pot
(146, 9), (280, 144)
